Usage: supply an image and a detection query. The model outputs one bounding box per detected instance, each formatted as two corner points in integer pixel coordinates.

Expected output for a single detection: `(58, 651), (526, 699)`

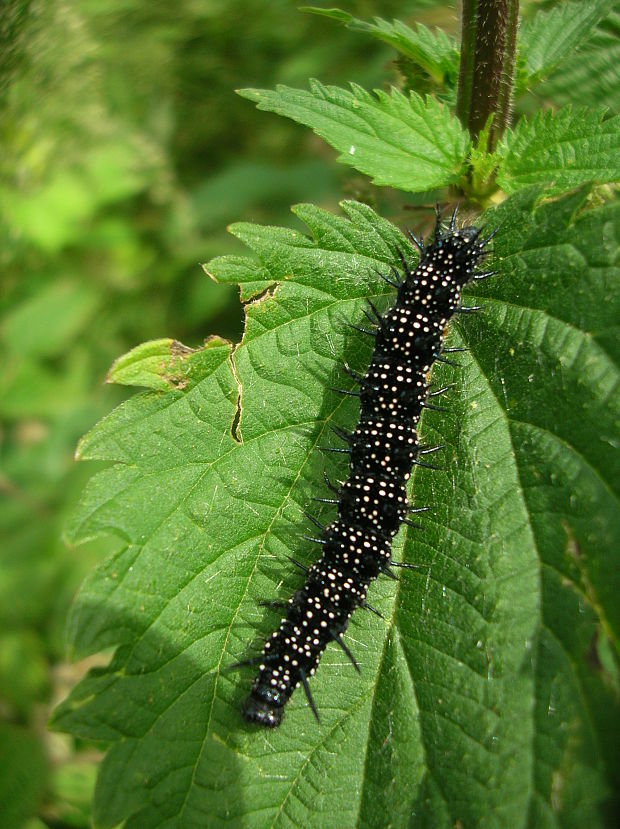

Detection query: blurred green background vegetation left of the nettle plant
(0, 0), (444, 829)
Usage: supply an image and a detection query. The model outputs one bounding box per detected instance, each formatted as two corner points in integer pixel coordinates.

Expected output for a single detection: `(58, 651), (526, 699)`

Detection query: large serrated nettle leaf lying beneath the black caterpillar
(55, 196), (620, 829)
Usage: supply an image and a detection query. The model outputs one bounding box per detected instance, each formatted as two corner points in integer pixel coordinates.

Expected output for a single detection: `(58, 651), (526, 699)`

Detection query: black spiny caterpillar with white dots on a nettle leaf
(239, 210), (495, 728)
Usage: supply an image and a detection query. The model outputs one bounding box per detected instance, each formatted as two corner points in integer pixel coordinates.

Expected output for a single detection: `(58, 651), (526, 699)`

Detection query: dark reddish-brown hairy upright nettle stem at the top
(457, 0), (519, 152)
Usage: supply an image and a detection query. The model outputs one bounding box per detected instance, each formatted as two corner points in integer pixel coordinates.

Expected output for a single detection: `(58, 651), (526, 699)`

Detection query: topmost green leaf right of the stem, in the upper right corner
(519, 0), (611, 91)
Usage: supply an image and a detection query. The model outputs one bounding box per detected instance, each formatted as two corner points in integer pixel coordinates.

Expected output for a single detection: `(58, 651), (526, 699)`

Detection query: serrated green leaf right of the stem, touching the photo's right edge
(497, 107), (620, 193)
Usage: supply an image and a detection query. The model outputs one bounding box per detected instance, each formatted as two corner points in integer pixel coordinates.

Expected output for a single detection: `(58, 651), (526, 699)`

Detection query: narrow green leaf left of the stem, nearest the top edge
(300, 6), (459, 87)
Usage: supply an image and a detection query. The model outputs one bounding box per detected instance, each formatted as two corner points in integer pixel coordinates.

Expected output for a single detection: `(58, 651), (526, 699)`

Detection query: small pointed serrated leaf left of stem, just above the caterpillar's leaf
(239, 80), (469, 192)
